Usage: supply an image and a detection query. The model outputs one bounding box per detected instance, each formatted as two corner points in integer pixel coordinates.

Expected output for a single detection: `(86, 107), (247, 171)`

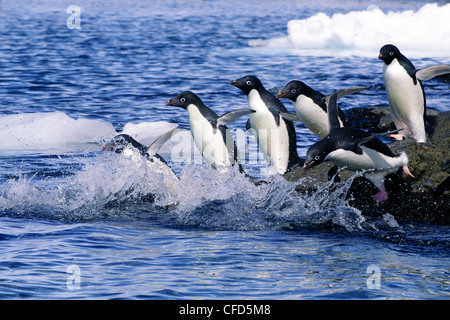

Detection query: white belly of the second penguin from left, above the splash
(187, 105), (231, 167)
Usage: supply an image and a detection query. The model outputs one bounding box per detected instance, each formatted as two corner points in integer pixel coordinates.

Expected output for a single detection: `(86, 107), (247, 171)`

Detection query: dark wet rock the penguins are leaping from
(285, 108), (450, 225)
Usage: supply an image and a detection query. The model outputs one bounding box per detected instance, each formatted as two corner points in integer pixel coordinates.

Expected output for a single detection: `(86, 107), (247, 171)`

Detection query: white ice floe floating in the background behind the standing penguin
(249, 3), (450, 57)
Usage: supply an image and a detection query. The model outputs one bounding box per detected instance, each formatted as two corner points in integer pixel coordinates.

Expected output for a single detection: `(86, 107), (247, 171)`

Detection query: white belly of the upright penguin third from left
(248, 90), (289, 174)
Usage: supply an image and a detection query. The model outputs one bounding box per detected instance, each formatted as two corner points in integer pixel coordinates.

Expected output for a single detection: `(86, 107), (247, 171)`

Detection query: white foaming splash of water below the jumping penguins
(0, 147), (398, 232)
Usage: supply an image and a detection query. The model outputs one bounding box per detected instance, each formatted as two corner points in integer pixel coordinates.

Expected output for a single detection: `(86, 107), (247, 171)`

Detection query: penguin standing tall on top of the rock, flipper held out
(378, 44), (450, 142)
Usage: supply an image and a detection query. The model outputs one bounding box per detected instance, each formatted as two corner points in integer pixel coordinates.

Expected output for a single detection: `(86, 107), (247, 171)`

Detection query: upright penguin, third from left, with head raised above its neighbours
(230, 76), (303, 174)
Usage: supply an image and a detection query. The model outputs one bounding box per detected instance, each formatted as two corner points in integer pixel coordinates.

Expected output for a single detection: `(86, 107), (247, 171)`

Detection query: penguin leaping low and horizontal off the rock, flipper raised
(304, 94), (414, 202)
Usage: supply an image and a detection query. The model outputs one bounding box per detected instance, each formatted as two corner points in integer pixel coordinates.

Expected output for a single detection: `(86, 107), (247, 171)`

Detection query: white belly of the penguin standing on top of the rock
(383, 59), (426, 142)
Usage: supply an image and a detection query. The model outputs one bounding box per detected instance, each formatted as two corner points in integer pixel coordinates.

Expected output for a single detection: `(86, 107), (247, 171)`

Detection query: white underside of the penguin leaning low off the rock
(326, 146), (408, 187)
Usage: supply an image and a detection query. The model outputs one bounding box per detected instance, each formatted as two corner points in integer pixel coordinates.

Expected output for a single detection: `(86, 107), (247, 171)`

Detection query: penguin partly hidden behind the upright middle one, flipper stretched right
(276, 80), (369, 139)
